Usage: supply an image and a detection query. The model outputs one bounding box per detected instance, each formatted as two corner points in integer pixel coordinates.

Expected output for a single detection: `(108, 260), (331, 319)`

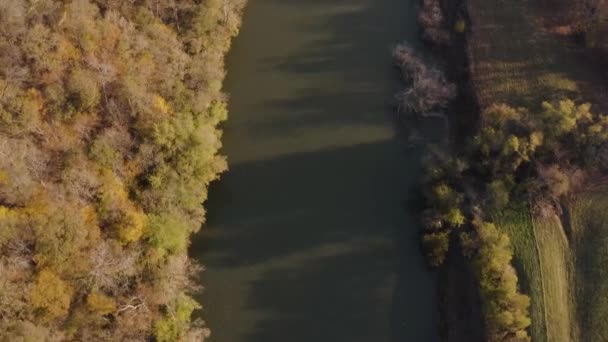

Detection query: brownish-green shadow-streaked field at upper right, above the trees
(468, 0), (606, 109)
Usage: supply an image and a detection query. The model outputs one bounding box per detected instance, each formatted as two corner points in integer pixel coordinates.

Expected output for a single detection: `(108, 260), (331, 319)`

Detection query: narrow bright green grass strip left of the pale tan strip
(492, 203), (547, 342)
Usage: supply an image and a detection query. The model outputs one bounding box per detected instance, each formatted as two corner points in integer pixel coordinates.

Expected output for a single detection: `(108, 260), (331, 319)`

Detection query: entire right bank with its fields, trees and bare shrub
(395, 0), (608, 341)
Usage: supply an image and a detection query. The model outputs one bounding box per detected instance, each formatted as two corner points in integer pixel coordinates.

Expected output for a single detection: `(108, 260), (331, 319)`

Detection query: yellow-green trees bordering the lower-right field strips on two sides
(423, 100), (608, 341)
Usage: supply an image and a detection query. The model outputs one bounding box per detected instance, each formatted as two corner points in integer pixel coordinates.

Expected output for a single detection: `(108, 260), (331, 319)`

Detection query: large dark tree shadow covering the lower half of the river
(192, 141), (435, 342)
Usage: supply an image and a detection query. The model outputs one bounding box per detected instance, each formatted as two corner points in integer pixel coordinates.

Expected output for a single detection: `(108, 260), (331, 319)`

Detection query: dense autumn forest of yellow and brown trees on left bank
(0, 0), (245, 341)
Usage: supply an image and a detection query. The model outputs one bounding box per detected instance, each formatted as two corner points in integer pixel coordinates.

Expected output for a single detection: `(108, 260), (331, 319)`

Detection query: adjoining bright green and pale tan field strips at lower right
(492, 203), (580, 342)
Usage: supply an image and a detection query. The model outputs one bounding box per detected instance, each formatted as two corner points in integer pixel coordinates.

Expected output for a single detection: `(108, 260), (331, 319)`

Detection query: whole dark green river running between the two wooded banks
(191, 0), (438, 342)
